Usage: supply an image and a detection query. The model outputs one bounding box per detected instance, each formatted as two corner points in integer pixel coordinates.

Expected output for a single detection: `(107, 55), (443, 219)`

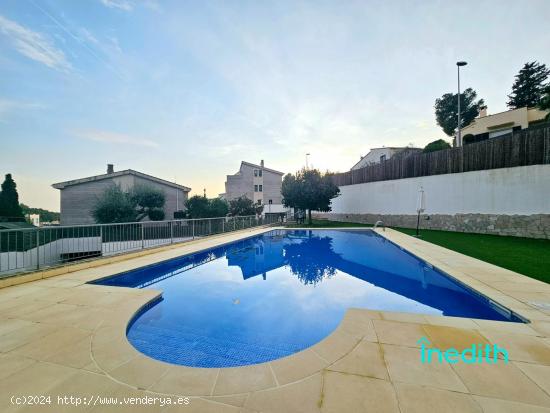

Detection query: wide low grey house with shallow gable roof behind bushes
(52, 164), (191, 225)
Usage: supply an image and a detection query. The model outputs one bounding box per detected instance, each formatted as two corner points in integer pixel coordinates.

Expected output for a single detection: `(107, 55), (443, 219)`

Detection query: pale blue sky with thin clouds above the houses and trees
(0, 0), (550, 211)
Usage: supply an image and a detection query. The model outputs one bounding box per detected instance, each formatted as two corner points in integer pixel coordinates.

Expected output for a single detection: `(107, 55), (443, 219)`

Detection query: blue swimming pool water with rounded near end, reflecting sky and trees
(91, 230), (520, 367)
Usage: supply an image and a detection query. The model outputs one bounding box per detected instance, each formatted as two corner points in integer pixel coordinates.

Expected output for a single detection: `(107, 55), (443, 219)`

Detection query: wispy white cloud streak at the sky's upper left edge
(0, 15), (71, 70)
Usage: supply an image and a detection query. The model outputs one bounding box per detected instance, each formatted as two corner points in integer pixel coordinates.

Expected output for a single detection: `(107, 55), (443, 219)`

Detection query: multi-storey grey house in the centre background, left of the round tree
(221, 160), (286, 214)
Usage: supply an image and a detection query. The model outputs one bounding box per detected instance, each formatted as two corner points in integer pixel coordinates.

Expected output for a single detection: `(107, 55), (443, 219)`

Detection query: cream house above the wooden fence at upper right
(460, 107), (549, 143)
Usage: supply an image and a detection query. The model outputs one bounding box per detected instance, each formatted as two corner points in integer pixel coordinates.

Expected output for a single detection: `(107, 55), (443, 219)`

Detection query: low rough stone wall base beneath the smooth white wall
(314, 213), (550, 239)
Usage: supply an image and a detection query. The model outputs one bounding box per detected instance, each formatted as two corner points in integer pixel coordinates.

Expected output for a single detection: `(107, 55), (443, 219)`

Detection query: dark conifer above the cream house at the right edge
(507, 62), (550, 109)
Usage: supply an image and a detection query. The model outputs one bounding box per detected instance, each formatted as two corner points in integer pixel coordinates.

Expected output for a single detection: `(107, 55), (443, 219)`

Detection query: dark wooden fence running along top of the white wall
(333, 126), (550, 186)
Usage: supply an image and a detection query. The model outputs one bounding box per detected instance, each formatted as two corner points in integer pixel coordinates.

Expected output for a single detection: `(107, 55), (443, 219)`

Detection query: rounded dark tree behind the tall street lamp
(435, 88), (485, 136)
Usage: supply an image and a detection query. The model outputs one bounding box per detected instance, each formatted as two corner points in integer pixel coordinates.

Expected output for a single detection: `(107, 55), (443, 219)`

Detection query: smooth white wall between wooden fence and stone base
(332, 165), (550, 215)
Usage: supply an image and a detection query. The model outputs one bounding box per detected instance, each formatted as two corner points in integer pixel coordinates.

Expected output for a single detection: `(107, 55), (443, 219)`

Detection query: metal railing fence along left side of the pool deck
(0, 215), (279, 277)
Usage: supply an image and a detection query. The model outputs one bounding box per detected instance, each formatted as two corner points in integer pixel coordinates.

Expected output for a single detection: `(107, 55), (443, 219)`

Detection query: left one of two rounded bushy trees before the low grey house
(92, 185), (138, 224)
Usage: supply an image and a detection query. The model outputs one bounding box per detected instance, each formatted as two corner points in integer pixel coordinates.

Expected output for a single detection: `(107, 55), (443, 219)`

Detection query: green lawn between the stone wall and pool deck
(286, 220), (550, 283)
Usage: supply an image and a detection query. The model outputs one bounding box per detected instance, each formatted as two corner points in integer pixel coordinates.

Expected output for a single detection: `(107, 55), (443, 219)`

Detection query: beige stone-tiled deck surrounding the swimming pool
(0, 228), (550, 413)
